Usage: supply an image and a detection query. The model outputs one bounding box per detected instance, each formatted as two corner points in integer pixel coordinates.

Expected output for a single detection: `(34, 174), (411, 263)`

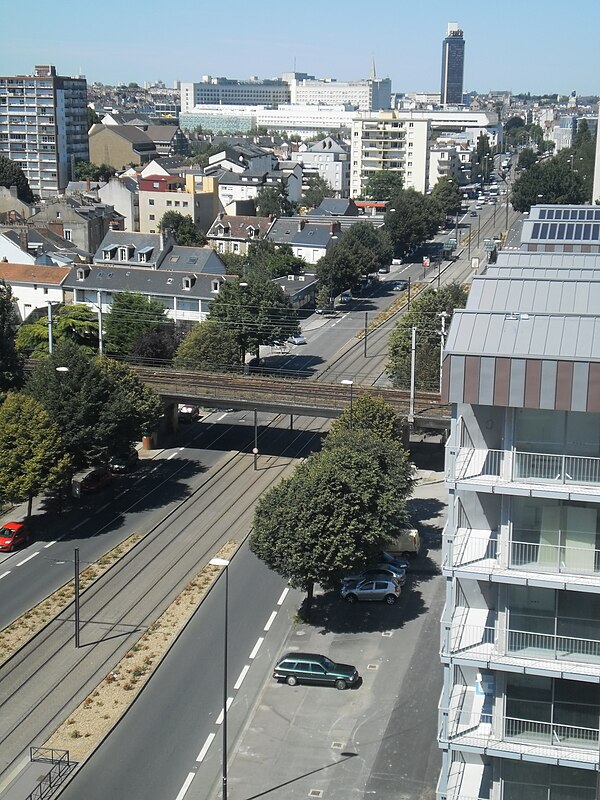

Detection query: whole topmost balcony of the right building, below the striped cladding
(446, 447), (600, 499)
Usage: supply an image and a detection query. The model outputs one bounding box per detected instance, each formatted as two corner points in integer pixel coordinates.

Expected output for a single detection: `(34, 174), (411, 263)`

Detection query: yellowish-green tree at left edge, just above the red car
(0, 392), (70, 516)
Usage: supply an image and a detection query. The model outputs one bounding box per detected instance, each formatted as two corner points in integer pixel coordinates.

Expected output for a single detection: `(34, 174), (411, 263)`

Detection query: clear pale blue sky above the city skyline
(0, 0), (600, 95)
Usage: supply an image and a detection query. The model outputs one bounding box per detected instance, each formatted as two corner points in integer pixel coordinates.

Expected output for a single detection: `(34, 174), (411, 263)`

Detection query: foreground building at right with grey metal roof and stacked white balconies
(438, 236), (600, 800)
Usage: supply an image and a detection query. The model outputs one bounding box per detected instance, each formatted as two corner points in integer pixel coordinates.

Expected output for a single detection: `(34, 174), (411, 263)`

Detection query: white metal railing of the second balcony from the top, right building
(444, 528), (600, 577)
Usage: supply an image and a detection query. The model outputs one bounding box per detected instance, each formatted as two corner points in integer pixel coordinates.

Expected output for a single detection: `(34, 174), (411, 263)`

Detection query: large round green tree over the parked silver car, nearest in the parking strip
(250, 431), (412, 612)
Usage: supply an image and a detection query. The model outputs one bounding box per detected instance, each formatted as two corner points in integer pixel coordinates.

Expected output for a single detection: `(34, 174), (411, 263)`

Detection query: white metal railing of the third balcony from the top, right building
(442, 621), (600, 673)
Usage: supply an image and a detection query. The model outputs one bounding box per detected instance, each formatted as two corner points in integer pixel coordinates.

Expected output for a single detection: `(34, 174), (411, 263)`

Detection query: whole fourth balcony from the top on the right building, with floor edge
(439, 708), (600, 769)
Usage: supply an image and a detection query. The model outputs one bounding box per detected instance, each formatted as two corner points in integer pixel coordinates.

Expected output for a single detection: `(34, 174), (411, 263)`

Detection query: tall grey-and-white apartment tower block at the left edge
(0, 66), (89, 197)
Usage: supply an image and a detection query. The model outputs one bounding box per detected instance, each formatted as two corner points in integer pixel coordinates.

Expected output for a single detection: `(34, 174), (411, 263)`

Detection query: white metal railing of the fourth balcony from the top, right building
(440, 713), (600, 763)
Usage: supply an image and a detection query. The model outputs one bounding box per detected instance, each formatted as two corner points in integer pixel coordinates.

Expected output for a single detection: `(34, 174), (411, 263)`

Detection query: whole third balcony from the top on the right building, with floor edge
(442, 620), (600, 680)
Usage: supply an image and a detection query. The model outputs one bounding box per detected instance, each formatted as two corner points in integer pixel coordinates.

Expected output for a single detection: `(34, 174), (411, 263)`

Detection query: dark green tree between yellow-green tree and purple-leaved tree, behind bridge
(105, 292), (171, 356)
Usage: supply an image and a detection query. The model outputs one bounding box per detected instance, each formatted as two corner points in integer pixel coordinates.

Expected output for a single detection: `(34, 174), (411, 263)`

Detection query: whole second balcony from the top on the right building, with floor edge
(442, 528), (600, 591)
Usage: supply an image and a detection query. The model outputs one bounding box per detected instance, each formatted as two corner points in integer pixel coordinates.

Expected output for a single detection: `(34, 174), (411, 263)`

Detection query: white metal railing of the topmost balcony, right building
(448, 447), (600, 486)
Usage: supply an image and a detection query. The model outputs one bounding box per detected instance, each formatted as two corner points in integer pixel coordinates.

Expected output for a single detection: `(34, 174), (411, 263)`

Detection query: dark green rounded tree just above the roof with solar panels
(511, 158), (590, 211)
